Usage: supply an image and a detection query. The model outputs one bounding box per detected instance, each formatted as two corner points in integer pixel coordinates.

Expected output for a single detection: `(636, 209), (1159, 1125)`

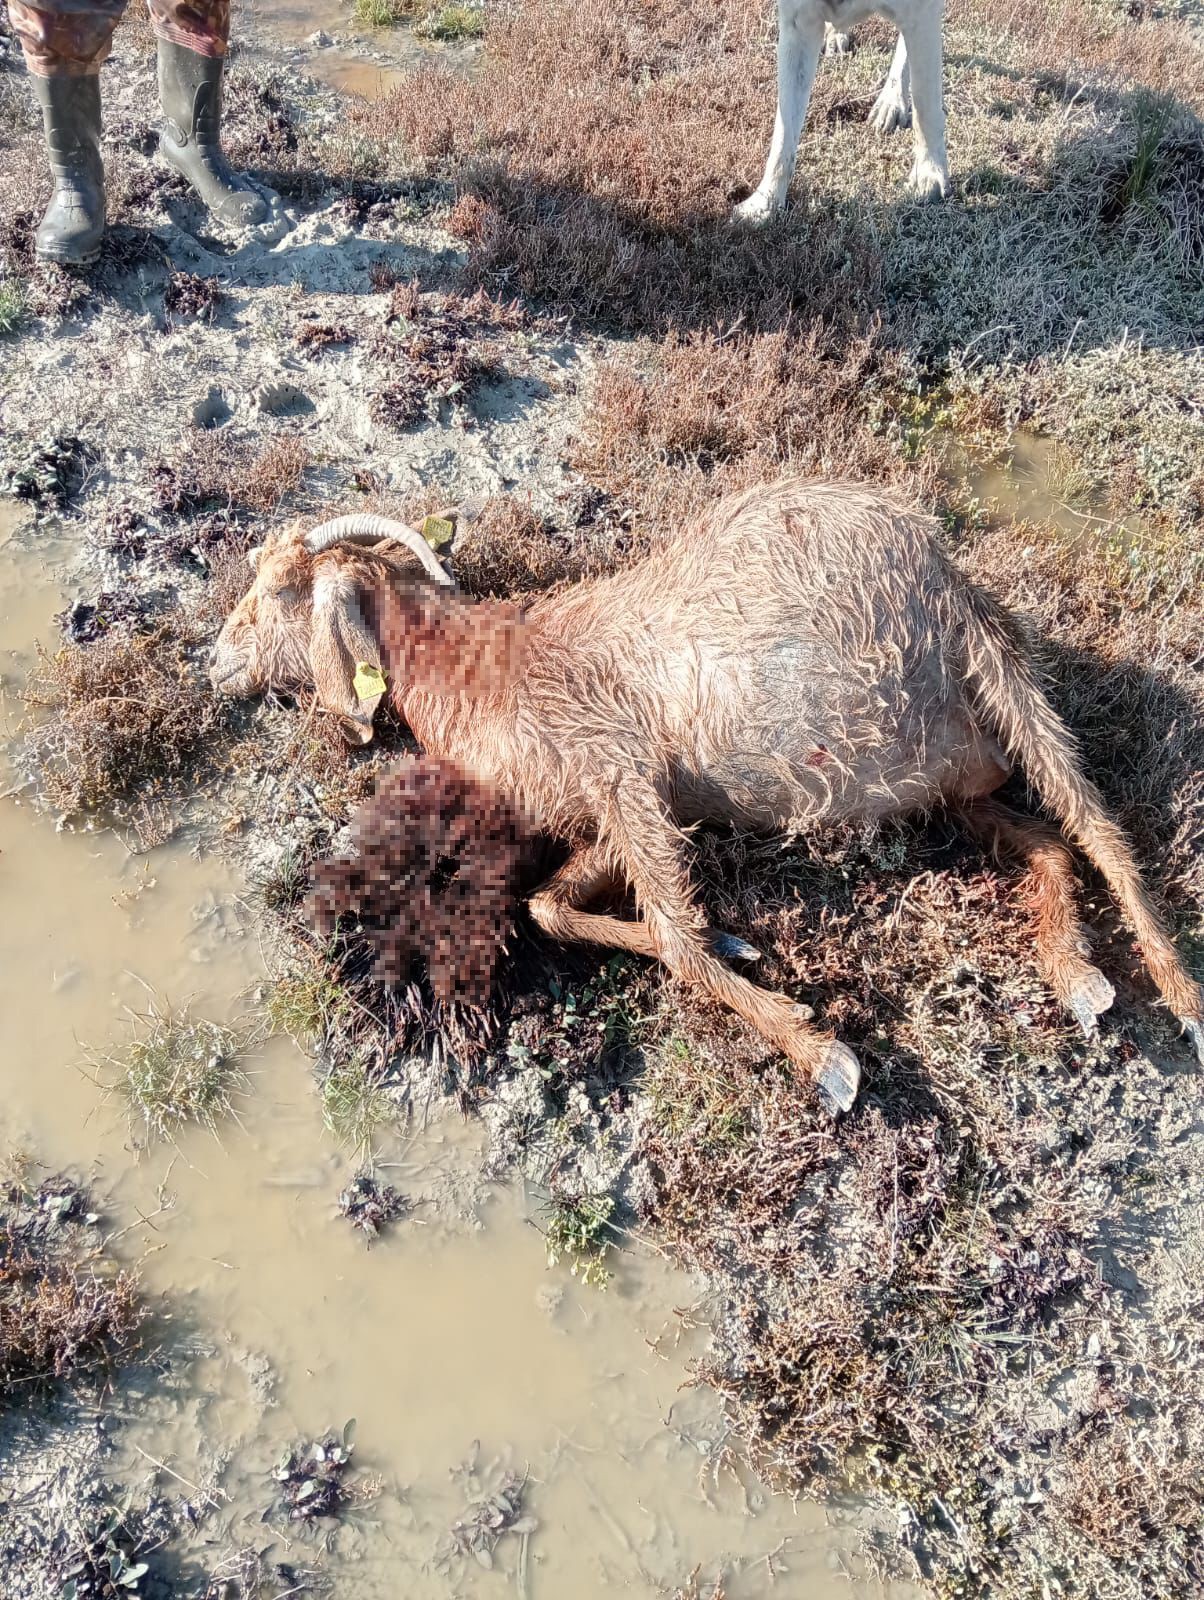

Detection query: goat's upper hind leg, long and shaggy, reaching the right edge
(965, 590), (1204, 1030)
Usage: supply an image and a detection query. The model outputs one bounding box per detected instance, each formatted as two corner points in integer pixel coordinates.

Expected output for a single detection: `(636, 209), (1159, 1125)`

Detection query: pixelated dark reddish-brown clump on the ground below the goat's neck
(307, 755), (535, 1006)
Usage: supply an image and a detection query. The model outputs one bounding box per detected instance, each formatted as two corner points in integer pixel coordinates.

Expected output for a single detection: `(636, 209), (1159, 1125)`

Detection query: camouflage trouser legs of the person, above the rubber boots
(8, 0), (231, 78)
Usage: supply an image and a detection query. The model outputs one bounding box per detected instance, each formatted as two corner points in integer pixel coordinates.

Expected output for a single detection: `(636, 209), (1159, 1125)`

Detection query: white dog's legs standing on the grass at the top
(735, 0), (949, 222)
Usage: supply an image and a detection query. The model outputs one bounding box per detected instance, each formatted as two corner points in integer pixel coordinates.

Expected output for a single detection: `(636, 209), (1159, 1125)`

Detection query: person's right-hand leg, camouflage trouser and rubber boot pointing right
(147, 0), (269, 227)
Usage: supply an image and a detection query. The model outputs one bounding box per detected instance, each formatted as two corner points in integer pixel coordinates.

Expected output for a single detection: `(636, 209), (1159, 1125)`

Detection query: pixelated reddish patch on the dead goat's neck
(381, 584), (527, 698)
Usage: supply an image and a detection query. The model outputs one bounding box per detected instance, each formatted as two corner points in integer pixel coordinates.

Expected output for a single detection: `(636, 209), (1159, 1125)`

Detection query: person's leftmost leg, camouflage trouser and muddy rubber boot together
(8, 0), (125, 267)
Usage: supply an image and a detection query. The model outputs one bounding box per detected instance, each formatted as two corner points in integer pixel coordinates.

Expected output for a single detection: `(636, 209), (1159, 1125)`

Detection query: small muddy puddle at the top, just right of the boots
(242, 0), (480, 99)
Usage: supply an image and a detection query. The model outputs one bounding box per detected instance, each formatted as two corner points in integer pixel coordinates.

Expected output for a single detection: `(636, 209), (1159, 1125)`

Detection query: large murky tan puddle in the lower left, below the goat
(0, 502), (903, 1600)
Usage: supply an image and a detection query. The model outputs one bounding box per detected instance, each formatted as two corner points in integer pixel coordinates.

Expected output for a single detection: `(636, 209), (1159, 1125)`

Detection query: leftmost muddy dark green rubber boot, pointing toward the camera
(29, 74), (104, 267)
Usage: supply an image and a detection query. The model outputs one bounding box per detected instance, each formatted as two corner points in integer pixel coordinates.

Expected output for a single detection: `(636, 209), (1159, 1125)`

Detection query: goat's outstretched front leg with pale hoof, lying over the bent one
(592, 778), (861, 1115)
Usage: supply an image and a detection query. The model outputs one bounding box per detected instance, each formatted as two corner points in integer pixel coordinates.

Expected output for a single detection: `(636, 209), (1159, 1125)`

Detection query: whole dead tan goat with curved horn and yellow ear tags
(211, 478), (1204, 1109)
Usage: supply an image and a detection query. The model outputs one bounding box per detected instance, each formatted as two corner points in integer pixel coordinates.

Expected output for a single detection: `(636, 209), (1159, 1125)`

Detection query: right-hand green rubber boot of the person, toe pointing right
(159, 38), (267, 227)
